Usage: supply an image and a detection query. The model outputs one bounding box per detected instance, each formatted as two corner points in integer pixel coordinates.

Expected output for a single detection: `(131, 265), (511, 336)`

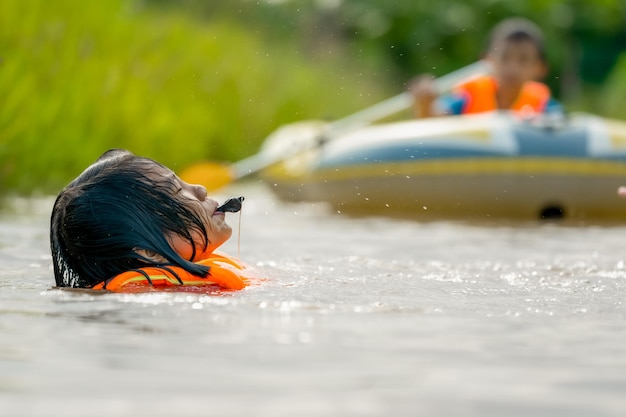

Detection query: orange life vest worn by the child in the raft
(456, 76), (550, 114)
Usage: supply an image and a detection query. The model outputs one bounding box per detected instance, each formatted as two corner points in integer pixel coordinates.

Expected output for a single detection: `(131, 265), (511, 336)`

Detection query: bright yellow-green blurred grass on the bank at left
(0, 0), (389, 194)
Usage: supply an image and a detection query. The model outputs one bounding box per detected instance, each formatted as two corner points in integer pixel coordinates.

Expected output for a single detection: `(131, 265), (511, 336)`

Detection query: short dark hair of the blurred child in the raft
(485, 17), (547, 63)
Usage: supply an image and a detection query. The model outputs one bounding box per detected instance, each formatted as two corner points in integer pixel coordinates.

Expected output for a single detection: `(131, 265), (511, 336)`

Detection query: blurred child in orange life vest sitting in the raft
(409, 18), (562, 117)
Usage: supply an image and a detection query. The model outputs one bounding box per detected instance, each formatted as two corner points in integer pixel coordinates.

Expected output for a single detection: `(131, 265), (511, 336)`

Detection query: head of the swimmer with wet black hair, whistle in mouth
(50, 150), (232, 288)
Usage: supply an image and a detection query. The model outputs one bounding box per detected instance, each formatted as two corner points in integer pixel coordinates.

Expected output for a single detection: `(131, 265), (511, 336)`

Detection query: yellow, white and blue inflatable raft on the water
(262, 112), (626, 221)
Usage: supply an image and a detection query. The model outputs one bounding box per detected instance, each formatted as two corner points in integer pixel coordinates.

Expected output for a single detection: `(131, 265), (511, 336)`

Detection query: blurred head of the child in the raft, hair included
(485, 18), (548, 88)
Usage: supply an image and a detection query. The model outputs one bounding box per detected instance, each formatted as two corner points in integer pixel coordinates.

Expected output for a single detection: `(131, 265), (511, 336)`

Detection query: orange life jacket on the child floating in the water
(92, 253), (256, 292)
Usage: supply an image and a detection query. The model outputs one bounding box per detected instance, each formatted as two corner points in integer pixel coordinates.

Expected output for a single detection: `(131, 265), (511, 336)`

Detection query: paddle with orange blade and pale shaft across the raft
(180, 61), (489, 191)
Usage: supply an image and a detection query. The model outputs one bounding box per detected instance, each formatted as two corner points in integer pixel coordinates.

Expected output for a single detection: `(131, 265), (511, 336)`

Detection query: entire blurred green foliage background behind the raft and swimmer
(0, 0), (626, 193)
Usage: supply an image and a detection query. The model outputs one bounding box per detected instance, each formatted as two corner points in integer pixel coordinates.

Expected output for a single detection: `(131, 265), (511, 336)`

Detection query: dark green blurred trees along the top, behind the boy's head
(167, 0), (626, 101)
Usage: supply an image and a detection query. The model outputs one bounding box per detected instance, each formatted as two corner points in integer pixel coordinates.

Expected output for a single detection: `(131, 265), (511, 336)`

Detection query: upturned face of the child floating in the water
(149, 166), (232, 261)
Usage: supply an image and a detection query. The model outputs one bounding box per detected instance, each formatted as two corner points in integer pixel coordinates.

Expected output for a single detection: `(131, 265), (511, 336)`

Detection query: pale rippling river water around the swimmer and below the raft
(0, 184), (626, 417)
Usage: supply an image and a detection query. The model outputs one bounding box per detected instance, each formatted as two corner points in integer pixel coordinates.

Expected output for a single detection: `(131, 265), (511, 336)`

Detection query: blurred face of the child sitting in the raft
(487, 40), (547, 88)
